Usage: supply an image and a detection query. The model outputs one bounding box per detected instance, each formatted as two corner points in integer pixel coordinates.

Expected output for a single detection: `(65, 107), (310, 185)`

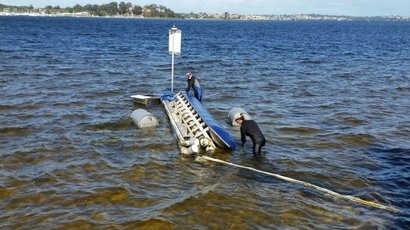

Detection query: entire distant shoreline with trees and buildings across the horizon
(0, 2), (410, 21)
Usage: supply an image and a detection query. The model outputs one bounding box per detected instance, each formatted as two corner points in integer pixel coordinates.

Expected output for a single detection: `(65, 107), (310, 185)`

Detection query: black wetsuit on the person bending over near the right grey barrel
(241, 120), (266, 155)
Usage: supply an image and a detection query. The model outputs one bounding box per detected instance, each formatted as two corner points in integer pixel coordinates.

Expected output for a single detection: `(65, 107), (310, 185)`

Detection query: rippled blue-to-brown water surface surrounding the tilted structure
(0, 17), (410, 229)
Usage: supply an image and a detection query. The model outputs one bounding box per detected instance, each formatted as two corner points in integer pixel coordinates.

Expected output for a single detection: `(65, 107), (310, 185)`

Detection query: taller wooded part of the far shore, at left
(0, 2), (183, 18)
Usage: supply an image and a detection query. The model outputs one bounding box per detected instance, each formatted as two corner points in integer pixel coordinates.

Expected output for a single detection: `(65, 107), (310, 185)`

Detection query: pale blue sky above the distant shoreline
(0, 0), (410, 17)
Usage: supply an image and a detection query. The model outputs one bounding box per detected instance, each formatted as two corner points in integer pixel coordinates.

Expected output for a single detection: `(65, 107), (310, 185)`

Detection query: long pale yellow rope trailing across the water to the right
(199, 156), (399, 213)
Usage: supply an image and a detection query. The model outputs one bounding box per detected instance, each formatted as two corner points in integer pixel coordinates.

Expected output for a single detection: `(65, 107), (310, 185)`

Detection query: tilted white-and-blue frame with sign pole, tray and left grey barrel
(131, 26), (235, 155)
